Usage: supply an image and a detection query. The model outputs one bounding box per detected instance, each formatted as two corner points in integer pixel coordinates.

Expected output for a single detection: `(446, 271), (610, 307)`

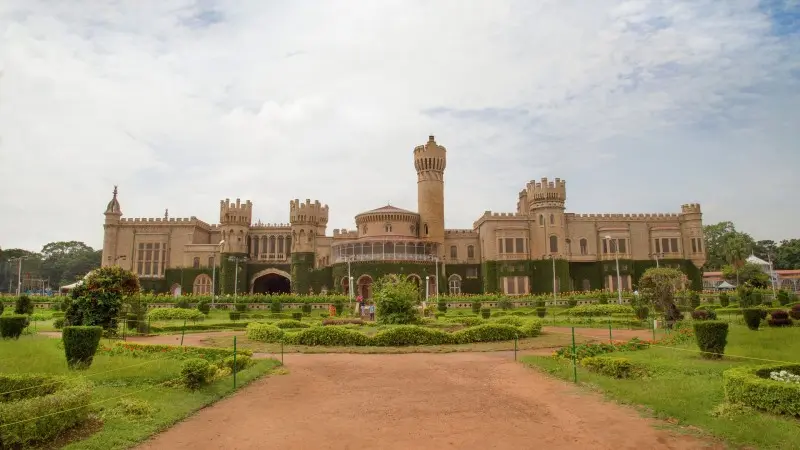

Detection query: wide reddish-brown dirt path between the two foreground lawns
(134, 353), (722, 450)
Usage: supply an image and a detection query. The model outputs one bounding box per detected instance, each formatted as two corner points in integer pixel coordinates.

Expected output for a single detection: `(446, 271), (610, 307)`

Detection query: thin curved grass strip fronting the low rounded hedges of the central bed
(203, 333), (593, 354)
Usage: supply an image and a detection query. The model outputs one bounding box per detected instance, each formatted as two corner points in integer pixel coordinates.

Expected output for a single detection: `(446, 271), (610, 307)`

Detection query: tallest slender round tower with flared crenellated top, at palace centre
(414, 136), (447, 258)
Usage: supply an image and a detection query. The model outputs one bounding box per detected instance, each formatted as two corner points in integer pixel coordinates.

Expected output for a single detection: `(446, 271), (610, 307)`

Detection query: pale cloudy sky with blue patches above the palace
(0, 0), (800, 250)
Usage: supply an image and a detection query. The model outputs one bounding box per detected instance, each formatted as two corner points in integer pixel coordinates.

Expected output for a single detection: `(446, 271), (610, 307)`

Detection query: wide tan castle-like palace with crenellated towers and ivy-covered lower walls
(103, 136), (706, 298)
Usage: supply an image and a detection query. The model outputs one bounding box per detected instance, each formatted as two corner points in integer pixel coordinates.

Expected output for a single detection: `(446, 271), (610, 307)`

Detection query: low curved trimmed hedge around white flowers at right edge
(722, 364), (800, 416)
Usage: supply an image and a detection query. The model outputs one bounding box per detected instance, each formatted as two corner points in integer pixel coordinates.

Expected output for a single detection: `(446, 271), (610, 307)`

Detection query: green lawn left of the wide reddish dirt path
(0, 336), (280, 450)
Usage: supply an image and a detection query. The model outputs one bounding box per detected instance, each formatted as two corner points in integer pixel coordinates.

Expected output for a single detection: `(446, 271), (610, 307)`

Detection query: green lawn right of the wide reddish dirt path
(522, 325), (800, 449)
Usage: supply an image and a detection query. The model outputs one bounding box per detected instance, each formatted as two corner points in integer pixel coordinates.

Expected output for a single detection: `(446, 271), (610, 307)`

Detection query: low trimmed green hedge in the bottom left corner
(0, 374), (92, 448)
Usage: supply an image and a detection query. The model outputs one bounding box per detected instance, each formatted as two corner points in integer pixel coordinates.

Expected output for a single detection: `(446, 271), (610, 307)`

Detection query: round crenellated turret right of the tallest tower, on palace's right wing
(520, 178), (567, 258)
